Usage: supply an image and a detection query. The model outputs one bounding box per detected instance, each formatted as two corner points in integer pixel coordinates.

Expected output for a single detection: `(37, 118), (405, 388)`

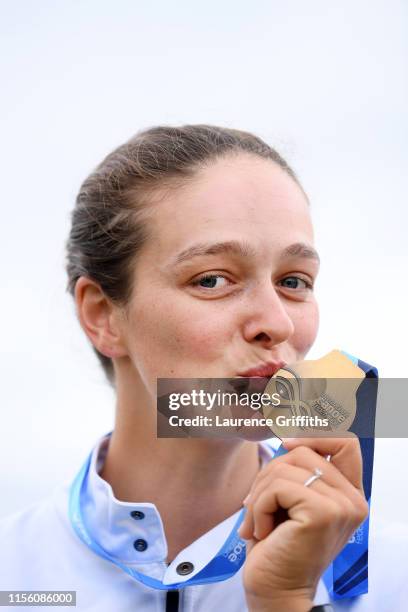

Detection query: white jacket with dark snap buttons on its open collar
(0, 437), (408, 612)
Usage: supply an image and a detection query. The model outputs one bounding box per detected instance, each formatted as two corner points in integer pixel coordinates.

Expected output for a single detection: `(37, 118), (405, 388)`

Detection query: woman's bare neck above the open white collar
(101, 366), (259, 561)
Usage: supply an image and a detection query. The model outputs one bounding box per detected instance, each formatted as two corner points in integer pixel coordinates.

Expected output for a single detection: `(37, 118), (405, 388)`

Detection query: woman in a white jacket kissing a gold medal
(1, 125), (402, 612)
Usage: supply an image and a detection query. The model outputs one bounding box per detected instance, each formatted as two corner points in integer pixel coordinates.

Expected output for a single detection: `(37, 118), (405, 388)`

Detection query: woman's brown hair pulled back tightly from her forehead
(66, 125), (301, 386)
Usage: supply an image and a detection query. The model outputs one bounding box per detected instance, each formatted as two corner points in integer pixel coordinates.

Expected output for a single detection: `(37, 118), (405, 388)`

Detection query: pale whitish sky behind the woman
(0, 0), (408, 520)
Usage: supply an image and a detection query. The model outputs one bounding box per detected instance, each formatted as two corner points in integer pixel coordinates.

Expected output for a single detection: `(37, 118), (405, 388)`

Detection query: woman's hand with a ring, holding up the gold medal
(239, 437), (368, 612)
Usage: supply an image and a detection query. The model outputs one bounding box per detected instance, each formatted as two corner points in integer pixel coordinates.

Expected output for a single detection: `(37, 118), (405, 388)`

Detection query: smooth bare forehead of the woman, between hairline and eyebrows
(142, 155), (313, 258)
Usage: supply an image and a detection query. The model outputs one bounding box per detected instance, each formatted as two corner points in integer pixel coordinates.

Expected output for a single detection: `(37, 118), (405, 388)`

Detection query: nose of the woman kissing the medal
(244, 281), (295, 349)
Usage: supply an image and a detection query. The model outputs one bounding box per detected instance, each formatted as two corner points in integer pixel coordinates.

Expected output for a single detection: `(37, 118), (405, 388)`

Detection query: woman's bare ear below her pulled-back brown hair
(75, 276), (127, 357)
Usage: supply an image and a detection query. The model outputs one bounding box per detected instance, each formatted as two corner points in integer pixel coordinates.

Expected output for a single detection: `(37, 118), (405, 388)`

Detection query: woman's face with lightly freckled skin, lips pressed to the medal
(119, 155), (318, 394)
